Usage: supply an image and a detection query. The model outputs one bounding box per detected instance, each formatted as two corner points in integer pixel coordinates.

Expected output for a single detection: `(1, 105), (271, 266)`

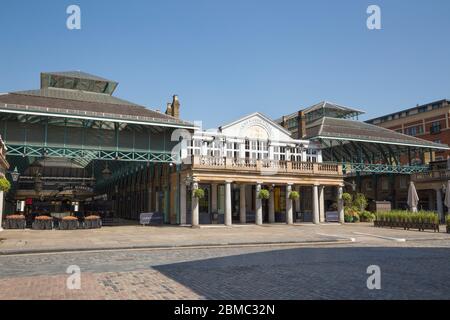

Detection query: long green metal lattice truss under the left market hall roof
(6, 144), (178, 165)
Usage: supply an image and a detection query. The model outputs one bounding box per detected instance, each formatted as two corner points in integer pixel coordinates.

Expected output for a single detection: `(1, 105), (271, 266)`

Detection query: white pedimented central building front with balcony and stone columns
(177, 113), (344, 227)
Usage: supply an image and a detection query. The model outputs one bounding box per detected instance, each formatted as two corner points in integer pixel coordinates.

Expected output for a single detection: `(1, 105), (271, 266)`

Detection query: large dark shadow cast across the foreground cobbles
(153, 247), (450, 299)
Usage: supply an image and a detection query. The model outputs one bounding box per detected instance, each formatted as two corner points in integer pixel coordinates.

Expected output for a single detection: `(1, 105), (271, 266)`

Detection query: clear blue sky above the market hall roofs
(0, 0), (450, 128)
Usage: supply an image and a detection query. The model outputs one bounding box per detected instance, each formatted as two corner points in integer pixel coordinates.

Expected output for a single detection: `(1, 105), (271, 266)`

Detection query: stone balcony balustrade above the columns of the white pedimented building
(192, 156), (342, 176)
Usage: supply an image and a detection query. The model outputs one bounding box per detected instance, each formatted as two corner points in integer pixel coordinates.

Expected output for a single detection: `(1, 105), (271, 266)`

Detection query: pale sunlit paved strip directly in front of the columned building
(0, 224), (450, 255)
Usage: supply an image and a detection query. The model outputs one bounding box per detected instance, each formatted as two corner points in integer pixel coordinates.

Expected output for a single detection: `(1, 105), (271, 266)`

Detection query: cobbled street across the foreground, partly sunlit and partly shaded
(0, 227), (450, 300)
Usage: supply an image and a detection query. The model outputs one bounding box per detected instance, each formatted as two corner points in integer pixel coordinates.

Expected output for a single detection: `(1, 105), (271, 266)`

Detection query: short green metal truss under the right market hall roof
(342, 162), (429, 174)
